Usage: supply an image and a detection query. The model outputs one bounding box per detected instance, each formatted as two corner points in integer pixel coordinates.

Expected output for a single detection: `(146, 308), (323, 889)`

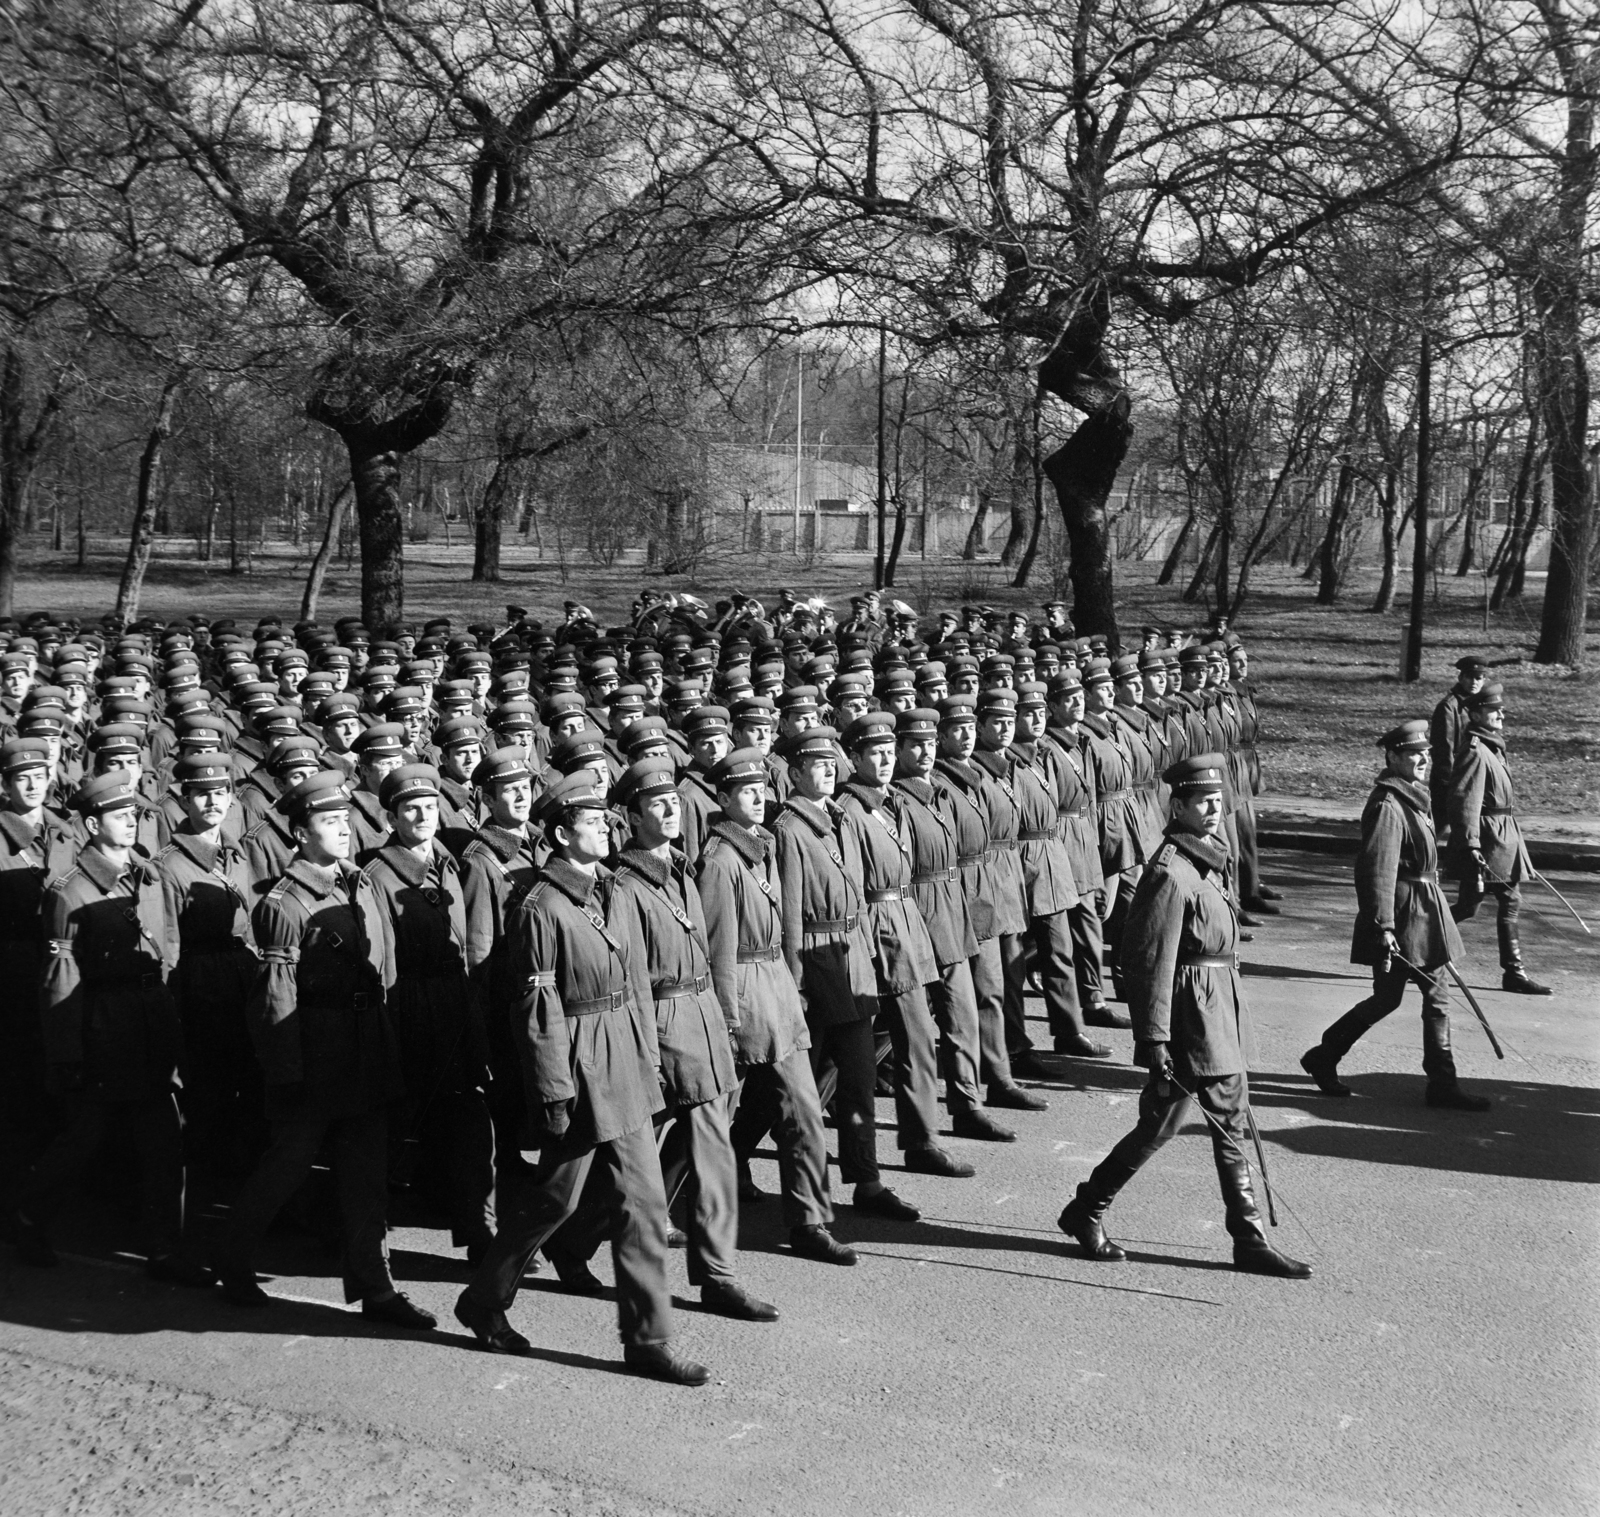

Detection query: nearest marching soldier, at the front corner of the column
(456, 775), (710, 1386)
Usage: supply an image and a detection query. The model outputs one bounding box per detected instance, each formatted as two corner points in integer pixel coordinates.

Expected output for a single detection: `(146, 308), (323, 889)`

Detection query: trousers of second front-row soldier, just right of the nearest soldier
(546, 1090), (739, 1285)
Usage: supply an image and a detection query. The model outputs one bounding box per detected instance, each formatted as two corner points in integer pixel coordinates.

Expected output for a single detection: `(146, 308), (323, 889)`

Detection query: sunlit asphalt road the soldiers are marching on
(0, 855), (1600, 1517)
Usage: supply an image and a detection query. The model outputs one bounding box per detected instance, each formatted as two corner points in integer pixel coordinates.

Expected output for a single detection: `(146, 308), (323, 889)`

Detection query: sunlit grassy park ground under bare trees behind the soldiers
(18, 542), (1600, 816)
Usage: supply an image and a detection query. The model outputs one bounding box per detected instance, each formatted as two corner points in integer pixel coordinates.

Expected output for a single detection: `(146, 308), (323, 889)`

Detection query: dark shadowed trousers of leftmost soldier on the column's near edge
(18, 1093), (184, 1259)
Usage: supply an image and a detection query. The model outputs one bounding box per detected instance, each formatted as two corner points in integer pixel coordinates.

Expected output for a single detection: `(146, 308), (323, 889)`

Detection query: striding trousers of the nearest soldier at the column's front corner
(466, 1122), (672, 1347)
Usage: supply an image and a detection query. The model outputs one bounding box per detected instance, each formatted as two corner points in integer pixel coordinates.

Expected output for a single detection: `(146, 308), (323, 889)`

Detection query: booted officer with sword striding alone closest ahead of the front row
(1059, 754), (1312, 1280)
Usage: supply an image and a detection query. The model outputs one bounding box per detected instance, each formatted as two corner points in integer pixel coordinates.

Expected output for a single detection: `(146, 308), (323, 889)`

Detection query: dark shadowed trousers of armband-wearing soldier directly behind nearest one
(214, 1103), (394, 1301)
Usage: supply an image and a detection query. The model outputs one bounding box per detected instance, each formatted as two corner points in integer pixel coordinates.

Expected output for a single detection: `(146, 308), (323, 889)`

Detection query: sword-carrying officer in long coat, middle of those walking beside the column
(1301, 720), (1490, 1112)
